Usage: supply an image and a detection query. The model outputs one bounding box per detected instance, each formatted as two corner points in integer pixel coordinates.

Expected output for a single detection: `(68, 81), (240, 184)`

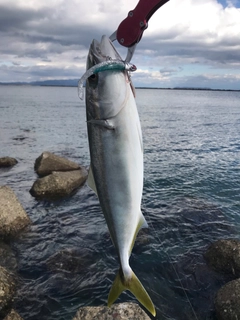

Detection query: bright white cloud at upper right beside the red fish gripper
(137, 0), (240, 59)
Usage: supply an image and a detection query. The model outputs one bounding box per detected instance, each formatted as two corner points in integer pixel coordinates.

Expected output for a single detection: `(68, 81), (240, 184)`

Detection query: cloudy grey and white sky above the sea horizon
(0, 0), (240, 90)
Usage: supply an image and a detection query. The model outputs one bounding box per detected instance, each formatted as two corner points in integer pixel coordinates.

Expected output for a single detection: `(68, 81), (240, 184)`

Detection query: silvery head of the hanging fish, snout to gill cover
(86, 36), (131, 120)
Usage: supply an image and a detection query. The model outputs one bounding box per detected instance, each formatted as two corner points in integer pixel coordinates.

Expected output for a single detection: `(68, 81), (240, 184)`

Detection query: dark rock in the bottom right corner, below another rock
(215, 279), (240, 320)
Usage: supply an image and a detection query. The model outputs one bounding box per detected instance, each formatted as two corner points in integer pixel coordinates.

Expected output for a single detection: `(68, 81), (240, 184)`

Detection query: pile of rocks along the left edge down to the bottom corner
(0, 182), (31, 320)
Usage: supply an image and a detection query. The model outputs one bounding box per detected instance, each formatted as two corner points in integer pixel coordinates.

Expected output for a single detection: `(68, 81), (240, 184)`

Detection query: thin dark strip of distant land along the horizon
(0, 82), (240, 92)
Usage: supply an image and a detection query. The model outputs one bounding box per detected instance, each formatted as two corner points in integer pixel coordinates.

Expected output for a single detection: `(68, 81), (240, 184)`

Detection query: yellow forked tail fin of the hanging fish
(108, 269), (156, 317)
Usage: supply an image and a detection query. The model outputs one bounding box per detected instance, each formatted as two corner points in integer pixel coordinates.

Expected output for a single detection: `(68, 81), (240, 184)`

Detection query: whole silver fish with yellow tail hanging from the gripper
(85, 36), (156, 316)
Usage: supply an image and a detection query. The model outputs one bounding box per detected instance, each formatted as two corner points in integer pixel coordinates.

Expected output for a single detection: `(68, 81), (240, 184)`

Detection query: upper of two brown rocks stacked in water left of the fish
(34, 152), (80, 177)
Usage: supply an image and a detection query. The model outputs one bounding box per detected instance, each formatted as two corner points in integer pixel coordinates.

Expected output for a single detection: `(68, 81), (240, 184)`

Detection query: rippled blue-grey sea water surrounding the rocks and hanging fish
(0, 86), (240, 320)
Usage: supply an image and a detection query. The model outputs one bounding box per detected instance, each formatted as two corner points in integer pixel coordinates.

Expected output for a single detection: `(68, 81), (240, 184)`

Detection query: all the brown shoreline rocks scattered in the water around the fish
(0, 152), (240, 320)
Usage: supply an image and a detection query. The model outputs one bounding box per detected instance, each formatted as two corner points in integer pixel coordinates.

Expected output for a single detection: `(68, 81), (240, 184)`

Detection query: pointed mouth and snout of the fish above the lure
(87, 36), (122, 69)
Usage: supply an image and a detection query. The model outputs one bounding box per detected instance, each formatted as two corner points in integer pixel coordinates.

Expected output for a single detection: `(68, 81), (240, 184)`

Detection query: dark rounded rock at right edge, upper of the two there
(204, 239), (240, 277)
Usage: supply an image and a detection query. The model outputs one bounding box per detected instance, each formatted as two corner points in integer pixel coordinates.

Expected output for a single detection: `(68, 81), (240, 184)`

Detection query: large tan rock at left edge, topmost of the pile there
(0, 186), (31, 239)
